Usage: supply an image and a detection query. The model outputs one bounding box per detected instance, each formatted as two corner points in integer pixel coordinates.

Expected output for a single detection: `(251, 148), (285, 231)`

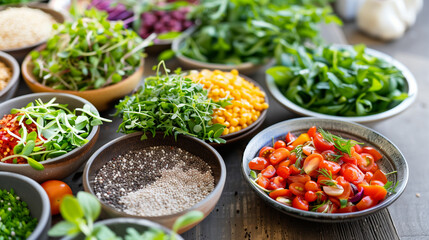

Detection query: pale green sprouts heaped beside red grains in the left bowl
(0, 98), (111, 170)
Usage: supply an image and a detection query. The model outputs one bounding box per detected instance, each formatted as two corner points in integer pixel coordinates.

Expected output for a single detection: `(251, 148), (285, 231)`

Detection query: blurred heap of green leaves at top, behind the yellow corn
(179, 0), (341, 65)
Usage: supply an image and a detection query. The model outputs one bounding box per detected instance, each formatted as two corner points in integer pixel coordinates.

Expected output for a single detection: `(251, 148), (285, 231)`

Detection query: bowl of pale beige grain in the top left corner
(0, 3), (66, 61)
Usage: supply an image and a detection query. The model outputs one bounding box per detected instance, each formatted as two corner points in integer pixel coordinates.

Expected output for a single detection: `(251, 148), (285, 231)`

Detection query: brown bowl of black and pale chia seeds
(83, 132), (226, 233)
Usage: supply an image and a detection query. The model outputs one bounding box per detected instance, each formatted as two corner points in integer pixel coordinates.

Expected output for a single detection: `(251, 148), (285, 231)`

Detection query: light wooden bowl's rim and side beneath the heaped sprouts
(21, 44), (145, 95)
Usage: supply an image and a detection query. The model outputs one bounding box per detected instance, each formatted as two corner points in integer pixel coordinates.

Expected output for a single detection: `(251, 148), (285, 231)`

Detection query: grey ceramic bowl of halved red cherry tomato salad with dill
(242, 118), (408, 222)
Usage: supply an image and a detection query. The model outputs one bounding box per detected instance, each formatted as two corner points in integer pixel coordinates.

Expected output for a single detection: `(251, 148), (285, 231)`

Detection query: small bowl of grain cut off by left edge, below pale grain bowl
(0, 51), (19, 102)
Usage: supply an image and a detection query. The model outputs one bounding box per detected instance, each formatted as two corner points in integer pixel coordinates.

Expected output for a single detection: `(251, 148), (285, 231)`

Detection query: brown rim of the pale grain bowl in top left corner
(0, 0), (67, 53)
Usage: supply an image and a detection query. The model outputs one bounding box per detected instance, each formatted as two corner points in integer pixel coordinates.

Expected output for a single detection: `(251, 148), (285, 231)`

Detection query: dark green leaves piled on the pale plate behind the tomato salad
(267, 45), (408, 116)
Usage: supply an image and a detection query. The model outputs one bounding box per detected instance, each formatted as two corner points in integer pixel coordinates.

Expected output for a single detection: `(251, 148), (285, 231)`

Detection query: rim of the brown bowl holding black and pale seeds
(82, 132), (227, 220)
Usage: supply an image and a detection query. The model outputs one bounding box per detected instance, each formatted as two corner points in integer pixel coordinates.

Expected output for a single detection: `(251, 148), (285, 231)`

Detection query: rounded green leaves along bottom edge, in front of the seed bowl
(48, 192), (204, 240)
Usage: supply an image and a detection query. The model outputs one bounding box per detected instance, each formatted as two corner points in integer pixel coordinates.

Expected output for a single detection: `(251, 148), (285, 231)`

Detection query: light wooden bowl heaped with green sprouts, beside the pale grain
(22, 9), (154, 111)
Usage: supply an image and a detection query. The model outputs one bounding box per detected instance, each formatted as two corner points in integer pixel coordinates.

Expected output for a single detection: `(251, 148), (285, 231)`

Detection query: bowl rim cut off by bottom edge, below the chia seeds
(62, 218), (183, 240)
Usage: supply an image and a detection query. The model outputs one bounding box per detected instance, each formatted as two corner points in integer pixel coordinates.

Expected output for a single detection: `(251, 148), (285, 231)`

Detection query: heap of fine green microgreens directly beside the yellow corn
(112, 62), (230, 143)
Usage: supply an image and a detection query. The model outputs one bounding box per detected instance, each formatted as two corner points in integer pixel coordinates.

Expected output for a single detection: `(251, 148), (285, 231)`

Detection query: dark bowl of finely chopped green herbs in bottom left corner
(0, 172), (51, 240)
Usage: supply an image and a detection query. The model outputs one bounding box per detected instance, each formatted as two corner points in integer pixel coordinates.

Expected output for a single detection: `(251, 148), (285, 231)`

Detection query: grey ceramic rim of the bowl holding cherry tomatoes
(241, 117), (409, 222)
